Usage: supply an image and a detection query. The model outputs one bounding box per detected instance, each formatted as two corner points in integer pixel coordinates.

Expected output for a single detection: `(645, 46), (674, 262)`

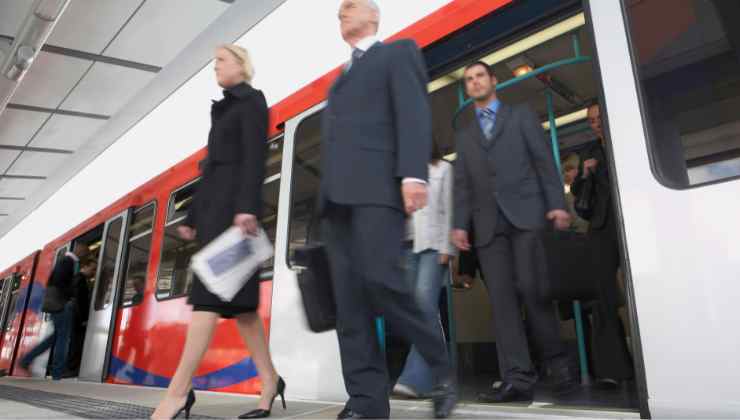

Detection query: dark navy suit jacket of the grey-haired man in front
(319, 40), (432, 213)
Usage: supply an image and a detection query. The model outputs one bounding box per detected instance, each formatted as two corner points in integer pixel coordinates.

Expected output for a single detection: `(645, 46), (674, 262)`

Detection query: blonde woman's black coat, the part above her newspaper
(185, 83), (267, 244)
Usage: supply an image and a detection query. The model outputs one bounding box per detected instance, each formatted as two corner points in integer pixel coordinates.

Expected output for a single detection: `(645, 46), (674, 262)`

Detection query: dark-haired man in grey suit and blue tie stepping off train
(452, 62), (574, 402)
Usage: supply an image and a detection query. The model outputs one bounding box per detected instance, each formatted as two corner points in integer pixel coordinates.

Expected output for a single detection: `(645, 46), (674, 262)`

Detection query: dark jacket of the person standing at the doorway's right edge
(571, 142), (612, 230)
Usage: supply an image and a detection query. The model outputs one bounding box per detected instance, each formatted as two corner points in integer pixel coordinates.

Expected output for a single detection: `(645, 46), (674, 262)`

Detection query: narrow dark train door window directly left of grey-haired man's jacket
(288, 113), (321, 261)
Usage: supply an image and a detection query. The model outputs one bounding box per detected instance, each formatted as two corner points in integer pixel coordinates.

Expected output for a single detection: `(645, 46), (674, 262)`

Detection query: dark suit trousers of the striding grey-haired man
(322, 204), (452, 418)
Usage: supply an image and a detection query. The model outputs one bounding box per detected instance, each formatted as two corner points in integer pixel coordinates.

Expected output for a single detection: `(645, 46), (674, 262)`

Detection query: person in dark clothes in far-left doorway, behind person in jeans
(62, 259), (98, 378)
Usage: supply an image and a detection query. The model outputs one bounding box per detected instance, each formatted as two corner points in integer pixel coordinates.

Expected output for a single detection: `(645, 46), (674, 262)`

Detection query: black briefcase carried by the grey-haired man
(293, 243), (337, 332)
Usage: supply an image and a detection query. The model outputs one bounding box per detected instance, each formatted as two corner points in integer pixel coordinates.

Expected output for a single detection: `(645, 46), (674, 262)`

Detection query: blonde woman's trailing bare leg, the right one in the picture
(236, 312), (278, 410)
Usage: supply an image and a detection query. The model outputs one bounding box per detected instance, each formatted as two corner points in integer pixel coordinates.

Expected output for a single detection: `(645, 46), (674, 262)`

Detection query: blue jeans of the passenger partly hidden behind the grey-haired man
(398, 250), (448, 395)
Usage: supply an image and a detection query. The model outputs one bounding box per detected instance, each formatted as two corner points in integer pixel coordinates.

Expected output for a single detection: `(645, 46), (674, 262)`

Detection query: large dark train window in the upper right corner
(624, 0), (740, 188)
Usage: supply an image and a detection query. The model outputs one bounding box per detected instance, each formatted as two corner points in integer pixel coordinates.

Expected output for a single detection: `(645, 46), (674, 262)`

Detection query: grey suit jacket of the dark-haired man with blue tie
(455, 103), (566, 247)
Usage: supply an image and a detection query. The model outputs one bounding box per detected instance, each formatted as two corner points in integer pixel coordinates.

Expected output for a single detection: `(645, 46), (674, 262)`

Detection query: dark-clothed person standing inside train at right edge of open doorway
(571, 103), (634, 385)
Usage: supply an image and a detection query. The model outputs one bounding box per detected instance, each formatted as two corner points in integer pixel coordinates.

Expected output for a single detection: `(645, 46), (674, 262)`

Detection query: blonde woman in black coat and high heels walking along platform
(152, 45), (285, 419)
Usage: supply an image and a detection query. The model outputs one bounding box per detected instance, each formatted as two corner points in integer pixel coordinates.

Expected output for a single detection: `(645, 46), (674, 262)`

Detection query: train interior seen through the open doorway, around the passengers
(388, 12), (638, 409)
